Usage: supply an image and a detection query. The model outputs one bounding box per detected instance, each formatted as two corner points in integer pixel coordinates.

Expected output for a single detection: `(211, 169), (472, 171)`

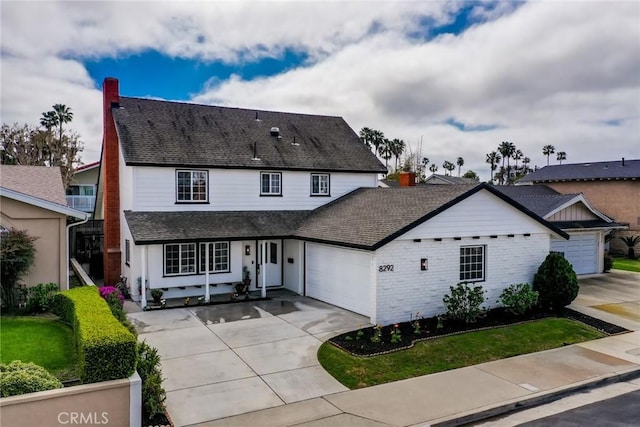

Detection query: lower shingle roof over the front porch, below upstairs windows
(124, 211), (310, 244)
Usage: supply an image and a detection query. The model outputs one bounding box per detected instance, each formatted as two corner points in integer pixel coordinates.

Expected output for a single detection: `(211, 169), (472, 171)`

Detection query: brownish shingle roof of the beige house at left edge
(0, 165), (67, 206)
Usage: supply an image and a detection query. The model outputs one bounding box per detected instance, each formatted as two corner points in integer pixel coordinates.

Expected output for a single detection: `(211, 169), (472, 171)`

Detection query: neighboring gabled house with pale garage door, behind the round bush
(495, 185), (627, 275)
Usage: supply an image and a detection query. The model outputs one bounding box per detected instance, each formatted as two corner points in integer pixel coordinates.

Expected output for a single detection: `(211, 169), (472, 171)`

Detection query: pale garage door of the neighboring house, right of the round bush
(551, 233), (599, 274)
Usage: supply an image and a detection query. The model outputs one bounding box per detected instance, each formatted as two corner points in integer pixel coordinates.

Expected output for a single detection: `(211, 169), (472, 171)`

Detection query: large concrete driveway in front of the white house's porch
(129, 291), (369, 426)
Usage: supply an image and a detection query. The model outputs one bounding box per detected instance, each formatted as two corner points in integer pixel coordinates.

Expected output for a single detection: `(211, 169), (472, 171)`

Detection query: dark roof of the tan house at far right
(518, 160), (640, 182)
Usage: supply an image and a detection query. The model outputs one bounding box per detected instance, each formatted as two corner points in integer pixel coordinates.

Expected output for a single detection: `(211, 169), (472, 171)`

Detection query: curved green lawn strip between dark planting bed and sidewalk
(318, 318), (604, 389)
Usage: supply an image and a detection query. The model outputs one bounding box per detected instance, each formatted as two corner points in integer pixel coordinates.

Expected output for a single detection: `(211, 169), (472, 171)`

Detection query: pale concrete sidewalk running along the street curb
(197, 332), (640, 427)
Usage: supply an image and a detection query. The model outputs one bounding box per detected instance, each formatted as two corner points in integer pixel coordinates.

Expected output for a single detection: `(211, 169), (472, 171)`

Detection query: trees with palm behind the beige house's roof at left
(0, 104), (83, 188)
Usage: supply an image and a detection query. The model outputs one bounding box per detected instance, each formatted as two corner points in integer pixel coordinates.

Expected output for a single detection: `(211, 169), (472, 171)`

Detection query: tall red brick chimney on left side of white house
(102, 77), (121, 285)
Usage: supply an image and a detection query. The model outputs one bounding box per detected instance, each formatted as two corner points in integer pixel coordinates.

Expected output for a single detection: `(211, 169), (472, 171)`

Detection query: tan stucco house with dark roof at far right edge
(517, 159), (640, 253)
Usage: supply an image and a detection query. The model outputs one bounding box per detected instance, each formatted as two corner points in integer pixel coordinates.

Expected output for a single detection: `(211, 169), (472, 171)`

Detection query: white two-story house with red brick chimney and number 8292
(97, 79), (568, 323)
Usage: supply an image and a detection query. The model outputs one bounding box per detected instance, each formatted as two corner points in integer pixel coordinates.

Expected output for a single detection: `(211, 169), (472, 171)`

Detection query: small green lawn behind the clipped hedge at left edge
(0, 317), (77, 380)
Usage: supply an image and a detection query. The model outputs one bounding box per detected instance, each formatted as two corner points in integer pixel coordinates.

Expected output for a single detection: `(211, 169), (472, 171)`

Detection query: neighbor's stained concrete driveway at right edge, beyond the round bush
(569, 270), (640, 331)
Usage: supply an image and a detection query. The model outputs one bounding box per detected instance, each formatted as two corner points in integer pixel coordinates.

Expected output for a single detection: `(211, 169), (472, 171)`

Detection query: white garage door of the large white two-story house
(306, 243), (371, 316)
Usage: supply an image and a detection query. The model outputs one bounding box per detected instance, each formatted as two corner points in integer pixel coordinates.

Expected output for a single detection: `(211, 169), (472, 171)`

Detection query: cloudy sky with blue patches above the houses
(0, 0), (640, 179)
